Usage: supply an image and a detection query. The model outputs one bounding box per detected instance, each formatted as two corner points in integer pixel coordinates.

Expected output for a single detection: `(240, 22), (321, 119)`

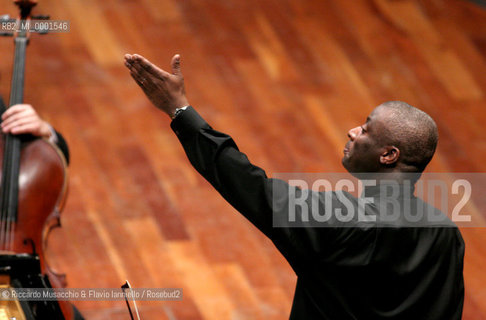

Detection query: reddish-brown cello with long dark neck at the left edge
(0, 0), (74, 319)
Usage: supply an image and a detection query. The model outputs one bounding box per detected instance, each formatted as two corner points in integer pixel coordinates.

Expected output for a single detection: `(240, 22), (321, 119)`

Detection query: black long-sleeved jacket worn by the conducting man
(171, 107), (464, 320)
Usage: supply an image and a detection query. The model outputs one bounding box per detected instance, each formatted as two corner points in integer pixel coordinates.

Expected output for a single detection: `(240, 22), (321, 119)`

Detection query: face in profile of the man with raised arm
(341, 106), (388, 173)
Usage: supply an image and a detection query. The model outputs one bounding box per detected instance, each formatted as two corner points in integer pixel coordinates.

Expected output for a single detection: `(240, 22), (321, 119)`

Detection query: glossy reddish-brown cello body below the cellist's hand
(0, 117), (74, 319)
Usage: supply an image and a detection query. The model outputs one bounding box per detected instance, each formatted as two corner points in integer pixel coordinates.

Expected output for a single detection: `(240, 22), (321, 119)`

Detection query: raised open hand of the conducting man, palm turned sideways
(125, 54), (189, 117)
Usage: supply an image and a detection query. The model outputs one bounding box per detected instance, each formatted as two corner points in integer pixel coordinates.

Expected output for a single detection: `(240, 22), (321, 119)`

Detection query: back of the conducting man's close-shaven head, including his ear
(373, 101), (439, 172)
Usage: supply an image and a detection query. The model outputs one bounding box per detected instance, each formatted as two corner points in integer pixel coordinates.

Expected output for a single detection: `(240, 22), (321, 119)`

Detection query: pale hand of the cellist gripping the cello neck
(2, 104), (52, 138)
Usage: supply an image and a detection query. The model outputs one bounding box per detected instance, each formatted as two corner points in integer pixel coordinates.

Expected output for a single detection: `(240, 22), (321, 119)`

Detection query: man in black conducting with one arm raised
(125, 54), (464, 320)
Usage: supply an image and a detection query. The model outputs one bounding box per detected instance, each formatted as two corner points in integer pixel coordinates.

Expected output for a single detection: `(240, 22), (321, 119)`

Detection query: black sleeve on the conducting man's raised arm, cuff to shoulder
(171, 107), (336, 272)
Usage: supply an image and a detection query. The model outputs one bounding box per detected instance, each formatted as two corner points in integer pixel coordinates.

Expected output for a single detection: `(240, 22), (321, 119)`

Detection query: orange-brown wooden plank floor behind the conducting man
(0, 0), (486, 320)
